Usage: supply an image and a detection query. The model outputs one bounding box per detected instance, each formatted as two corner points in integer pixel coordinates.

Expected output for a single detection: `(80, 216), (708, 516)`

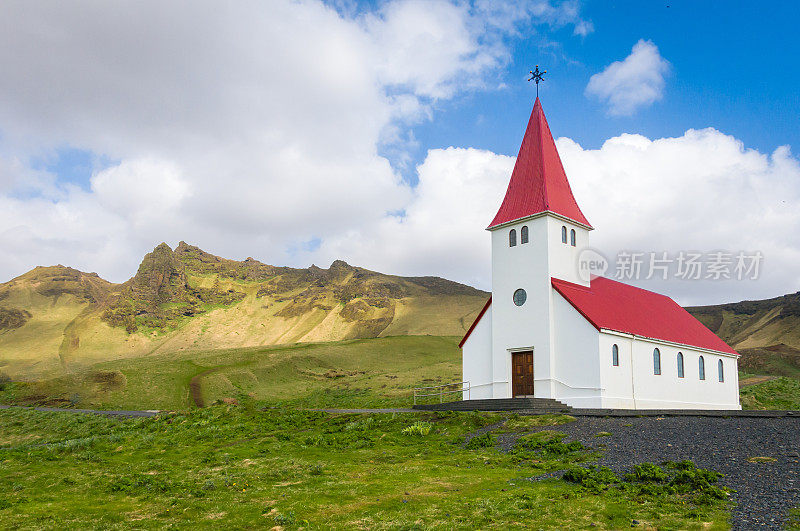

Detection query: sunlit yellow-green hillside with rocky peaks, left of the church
(0, 242), (488, 380)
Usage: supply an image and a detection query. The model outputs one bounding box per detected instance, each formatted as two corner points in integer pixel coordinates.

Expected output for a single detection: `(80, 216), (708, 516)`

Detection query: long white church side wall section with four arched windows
(632, 338), (741, 409)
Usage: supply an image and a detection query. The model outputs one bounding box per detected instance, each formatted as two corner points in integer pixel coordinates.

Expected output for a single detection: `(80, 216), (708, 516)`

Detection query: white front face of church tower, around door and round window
(491, 216), (552, 398)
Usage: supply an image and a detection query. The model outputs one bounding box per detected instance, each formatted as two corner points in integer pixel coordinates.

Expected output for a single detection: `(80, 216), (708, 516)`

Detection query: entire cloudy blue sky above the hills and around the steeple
(0, 0), (800, 304)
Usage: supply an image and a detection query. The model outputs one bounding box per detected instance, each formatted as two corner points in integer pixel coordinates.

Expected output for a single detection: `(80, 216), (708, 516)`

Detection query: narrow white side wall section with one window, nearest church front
(598, 333), (636, 409)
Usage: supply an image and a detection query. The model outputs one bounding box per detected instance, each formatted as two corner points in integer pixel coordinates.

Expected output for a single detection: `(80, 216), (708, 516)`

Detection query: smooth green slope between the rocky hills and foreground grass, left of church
(0, 336), (461, 410)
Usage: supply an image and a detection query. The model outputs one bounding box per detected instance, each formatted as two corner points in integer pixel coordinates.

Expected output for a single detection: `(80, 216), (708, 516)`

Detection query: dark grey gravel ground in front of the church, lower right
(498, 417), (800, 529)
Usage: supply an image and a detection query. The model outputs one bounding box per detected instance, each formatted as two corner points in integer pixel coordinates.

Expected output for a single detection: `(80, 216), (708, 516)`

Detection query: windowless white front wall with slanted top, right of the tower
(552, 290), (602, 408)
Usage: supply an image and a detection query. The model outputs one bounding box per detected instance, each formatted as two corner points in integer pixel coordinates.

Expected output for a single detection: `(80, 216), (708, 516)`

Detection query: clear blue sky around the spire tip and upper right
(398, 1), (800, 181)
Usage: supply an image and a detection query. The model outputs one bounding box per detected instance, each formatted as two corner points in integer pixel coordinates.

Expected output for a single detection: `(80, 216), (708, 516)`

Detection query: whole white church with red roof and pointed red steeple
(460, 97), (741, 409)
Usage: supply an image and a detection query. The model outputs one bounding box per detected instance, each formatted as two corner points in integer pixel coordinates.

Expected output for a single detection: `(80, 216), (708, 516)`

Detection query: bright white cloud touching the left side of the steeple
(313, 147), (514, 287)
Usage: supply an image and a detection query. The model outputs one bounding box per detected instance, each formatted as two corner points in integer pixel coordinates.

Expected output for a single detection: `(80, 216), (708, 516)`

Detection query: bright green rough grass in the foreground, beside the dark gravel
(0, 402), (728, 529)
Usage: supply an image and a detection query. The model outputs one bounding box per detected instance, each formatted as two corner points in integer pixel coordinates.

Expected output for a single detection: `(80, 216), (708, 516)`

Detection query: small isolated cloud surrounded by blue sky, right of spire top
(576, 40), (669, 116)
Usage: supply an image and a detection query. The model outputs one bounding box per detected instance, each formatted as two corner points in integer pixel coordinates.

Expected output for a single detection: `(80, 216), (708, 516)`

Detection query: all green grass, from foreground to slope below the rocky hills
(6, 336), (800, 529)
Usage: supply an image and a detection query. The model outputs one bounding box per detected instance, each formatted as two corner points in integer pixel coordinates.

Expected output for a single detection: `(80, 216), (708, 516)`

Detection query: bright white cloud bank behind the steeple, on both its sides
(314, 129), (800, 304)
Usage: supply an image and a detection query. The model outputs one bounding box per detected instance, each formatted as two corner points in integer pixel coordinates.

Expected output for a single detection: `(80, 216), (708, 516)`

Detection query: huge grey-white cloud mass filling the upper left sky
(0, 0), (581, 281)
